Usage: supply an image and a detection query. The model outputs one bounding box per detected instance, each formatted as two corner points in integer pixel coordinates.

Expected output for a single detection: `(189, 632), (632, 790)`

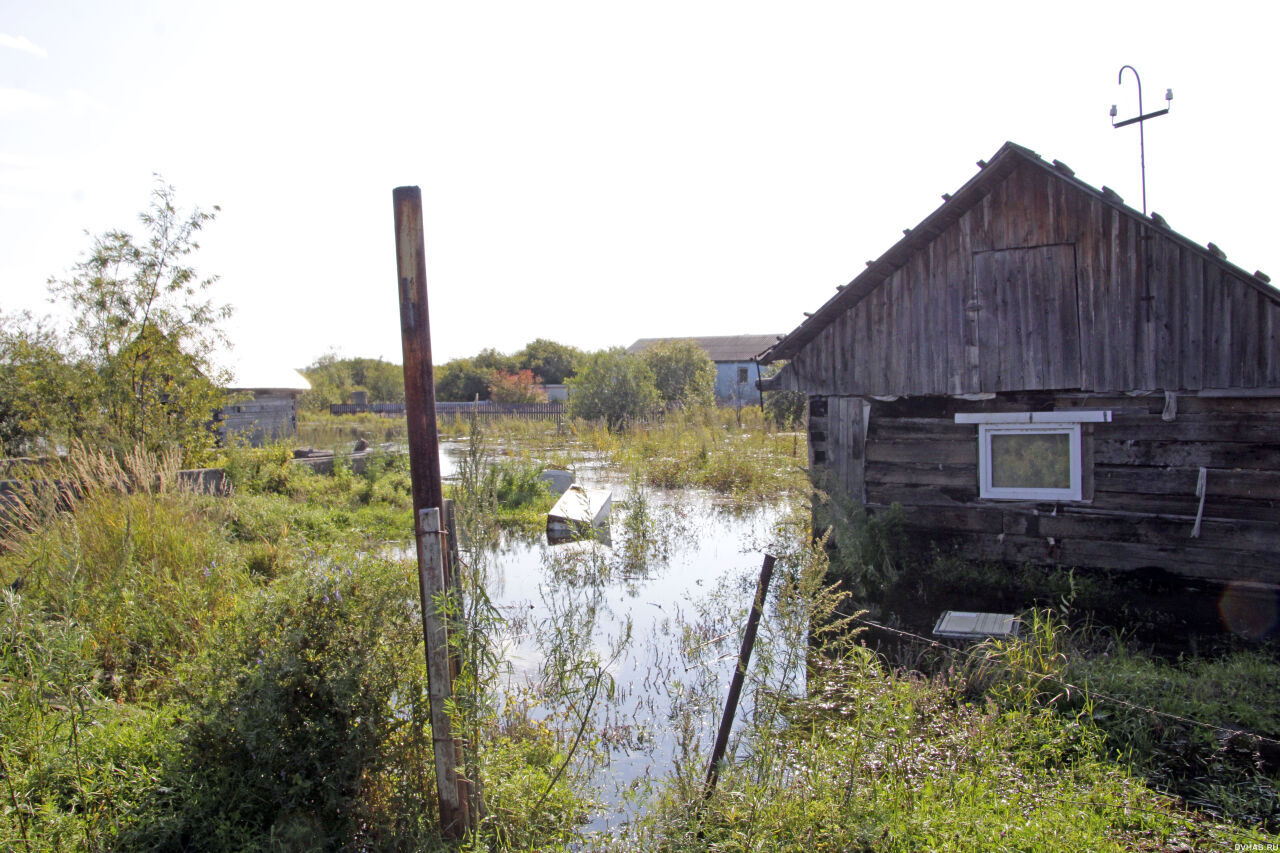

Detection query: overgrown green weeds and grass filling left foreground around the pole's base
(0, 440), (581, 850)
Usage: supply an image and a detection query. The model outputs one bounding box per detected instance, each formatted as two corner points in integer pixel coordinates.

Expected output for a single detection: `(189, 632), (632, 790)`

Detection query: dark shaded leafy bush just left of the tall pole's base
(125, 560), (434, 850)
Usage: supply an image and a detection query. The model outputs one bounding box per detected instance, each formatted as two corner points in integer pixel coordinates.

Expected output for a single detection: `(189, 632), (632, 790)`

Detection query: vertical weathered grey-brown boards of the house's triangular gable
(783, 163), (1280, 396)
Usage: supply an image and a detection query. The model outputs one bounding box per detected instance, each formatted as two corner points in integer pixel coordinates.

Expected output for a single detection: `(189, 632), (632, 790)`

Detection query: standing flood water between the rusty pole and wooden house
(442, 438), (786, 831)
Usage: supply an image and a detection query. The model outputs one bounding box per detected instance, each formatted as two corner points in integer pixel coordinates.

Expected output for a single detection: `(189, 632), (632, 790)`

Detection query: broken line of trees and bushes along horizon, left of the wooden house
(0, 177), (797, 464)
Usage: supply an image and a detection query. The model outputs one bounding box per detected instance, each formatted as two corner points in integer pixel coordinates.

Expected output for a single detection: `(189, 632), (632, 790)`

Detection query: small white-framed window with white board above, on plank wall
(956, 411), (1111, 501)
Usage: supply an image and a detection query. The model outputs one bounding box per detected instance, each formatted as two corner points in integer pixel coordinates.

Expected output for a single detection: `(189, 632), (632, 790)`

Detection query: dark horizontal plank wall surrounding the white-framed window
(828, 394), (1280, 584)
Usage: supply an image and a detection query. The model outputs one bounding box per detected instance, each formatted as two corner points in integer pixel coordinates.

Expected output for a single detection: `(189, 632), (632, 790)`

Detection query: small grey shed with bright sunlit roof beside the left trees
(214, 364), (311, 447)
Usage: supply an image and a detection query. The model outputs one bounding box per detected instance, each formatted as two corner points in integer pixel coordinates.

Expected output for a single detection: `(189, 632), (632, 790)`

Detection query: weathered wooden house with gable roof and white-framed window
(762, 143), (1280, 585)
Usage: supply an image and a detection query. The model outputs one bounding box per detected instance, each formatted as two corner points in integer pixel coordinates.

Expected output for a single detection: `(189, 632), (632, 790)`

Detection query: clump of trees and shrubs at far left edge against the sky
(0, 179), (230, 464)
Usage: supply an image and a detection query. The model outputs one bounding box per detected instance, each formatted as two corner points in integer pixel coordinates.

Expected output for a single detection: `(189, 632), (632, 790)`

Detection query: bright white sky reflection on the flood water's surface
(460, 458), (780, 830)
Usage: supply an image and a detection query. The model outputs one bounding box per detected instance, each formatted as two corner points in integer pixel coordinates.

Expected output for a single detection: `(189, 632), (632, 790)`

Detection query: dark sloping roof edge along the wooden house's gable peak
(760, 142), (1280, 364)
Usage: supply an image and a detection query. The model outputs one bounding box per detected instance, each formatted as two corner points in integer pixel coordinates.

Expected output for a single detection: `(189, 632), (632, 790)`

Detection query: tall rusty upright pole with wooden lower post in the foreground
(392, 187), (470, 838)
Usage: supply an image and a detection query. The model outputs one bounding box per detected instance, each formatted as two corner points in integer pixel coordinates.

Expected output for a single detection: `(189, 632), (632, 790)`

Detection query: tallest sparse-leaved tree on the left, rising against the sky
(39, 179), (230, 460)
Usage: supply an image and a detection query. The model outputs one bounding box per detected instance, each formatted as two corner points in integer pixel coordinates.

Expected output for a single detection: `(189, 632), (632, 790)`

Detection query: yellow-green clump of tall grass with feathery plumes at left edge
(0, 450), (247, 697)
